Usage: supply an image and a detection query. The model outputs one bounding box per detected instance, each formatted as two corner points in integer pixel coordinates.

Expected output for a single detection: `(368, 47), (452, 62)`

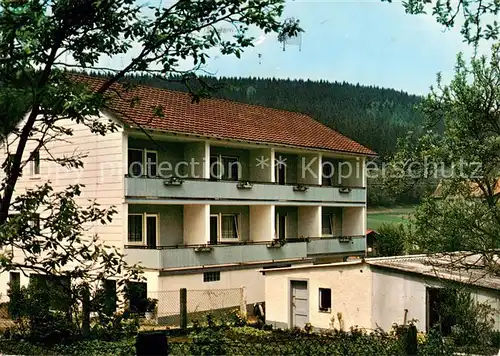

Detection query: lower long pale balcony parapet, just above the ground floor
(125, 236), (365, 270)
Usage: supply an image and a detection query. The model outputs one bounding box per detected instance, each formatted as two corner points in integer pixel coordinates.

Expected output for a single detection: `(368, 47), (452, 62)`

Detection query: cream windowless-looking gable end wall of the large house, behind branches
(0, 115), (127, 248)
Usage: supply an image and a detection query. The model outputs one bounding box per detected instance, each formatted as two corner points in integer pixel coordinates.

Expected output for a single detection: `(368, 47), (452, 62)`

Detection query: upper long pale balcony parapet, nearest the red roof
(125, 177), (366, 204)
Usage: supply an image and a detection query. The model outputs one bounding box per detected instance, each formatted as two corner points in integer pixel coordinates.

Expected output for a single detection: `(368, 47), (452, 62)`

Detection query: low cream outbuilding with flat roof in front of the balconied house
(262, 255), (500, 331)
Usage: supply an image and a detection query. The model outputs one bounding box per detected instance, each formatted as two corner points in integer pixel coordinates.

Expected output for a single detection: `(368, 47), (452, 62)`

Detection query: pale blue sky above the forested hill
(99, 0), (489, 95)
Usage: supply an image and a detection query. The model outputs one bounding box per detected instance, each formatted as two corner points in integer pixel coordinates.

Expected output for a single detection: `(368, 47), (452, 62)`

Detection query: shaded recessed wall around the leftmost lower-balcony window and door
(128, 204), (184, 246)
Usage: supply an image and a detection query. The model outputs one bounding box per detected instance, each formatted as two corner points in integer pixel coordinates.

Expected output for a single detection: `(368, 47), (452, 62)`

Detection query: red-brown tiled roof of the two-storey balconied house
(71, 75), (375, 155)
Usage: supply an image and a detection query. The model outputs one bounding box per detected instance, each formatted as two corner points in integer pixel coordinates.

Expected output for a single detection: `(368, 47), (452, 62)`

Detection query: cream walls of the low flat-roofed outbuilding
(265, 263), (500, 331)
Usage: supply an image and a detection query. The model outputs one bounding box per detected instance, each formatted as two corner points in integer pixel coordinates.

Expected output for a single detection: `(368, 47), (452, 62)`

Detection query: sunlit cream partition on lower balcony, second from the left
(249, 205), (275, 241)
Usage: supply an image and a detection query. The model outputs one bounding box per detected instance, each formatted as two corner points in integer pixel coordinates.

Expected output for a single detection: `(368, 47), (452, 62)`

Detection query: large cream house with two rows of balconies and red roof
(0, 76), (374, 316)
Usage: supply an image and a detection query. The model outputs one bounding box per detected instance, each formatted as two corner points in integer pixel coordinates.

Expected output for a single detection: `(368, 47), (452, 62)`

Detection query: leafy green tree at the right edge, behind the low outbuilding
(388, 44), (500, 275)
